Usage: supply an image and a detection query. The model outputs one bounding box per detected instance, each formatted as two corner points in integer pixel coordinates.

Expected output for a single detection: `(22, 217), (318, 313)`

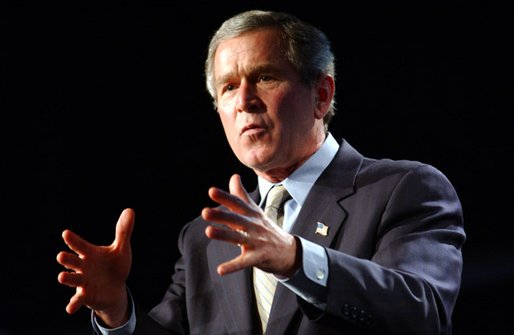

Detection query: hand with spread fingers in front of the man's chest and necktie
(202, 174), (301, 277)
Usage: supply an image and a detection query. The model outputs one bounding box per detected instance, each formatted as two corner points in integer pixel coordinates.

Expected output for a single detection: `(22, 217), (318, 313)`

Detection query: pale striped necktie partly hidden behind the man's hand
(253, 185), (291, 333)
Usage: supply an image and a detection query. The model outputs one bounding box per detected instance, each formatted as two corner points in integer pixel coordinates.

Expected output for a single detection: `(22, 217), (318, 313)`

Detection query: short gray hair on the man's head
(205, 10), (335, 130)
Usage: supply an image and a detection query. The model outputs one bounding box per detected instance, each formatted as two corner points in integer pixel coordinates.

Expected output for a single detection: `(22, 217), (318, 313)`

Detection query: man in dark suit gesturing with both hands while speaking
(57, 11), (465, 334)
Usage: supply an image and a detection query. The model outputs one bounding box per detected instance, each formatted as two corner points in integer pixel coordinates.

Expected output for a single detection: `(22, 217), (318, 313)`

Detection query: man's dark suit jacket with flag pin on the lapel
(129, 140), (465, 335)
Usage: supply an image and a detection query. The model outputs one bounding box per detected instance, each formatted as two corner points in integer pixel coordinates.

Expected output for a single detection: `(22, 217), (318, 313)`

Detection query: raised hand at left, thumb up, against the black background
(57, 209), (135, 327)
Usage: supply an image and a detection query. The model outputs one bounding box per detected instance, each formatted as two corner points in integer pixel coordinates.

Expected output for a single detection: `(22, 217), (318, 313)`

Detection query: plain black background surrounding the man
(0, 1), (514, 335)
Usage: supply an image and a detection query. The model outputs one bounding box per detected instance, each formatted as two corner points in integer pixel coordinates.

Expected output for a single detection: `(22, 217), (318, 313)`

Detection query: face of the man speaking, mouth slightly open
(214, 29), (323, 180)
